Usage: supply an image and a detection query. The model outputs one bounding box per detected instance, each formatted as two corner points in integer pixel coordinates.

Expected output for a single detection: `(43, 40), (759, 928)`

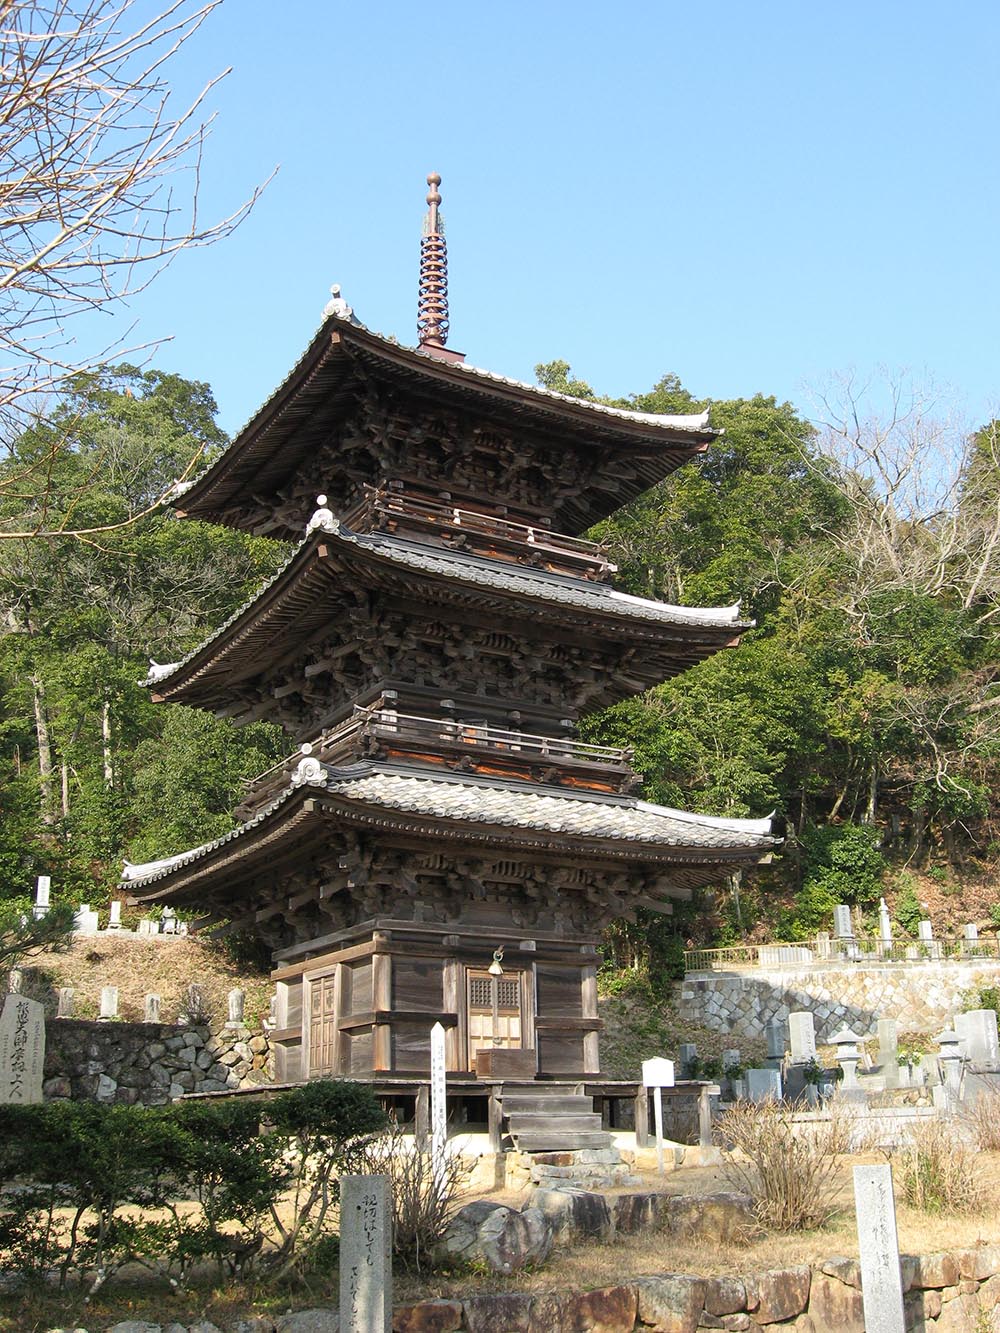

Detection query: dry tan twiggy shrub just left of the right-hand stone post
(717, 1101), (851, 1232)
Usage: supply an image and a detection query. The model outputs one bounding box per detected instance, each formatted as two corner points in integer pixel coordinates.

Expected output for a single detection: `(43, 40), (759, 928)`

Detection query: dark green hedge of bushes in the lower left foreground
(0, 1082), (385, 1294)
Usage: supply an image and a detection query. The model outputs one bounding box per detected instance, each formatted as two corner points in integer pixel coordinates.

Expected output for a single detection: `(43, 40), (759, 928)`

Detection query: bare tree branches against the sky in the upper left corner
(0, 0), (270, 536)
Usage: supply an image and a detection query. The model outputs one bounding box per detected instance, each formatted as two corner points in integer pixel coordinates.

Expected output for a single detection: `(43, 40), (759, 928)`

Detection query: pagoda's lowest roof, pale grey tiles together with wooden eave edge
(121, 758), (779, 901)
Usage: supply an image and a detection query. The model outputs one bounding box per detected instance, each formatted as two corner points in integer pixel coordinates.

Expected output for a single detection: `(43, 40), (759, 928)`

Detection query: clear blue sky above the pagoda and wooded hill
(121, 0), (1000, 431)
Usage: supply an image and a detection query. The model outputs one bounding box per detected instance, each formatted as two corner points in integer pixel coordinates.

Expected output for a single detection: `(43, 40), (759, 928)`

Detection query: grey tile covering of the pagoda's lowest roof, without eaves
(123, 760), (777, 886)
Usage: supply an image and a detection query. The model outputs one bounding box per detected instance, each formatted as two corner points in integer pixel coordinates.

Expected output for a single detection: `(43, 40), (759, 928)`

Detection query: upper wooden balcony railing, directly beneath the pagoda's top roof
(343, 487), (617, 581)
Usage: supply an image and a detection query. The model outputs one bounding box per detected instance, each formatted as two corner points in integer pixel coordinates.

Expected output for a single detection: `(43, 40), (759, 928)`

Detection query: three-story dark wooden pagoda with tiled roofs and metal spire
(125, 169), (775, 1125)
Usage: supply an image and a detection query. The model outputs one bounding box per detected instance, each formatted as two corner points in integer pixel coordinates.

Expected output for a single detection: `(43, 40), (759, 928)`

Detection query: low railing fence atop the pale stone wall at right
(684, 934), (1000, 973)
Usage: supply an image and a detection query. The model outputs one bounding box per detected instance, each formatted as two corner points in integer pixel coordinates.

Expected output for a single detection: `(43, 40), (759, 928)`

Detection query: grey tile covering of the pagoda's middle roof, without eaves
(145, 509), (751, 685)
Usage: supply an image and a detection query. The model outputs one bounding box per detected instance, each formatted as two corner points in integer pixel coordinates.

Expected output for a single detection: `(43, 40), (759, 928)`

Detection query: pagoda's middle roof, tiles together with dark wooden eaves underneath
(145, 509), (752, 708)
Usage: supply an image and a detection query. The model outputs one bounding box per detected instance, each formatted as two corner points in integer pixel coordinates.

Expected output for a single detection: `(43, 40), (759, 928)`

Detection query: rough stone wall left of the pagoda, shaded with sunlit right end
(43, 1018), (273, 1106)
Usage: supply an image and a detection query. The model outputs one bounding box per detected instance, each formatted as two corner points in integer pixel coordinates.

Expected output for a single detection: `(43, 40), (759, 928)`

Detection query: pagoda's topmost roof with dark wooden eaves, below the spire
(173, 313), (720, 533)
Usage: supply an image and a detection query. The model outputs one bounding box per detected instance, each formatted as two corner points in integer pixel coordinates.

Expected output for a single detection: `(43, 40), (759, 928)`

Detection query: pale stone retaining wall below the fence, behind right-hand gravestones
(676, 960), (1000, 1044)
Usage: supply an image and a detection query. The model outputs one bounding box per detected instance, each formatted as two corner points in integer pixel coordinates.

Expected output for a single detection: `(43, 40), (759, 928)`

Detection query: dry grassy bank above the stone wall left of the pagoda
(9, 934), (272, 1026)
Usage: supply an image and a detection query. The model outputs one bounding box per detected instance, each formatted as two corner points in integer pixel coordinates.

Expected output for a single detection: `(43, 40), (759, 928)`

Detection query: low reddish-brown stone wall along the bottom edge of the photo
(394, 1245), (1000, 1333)
